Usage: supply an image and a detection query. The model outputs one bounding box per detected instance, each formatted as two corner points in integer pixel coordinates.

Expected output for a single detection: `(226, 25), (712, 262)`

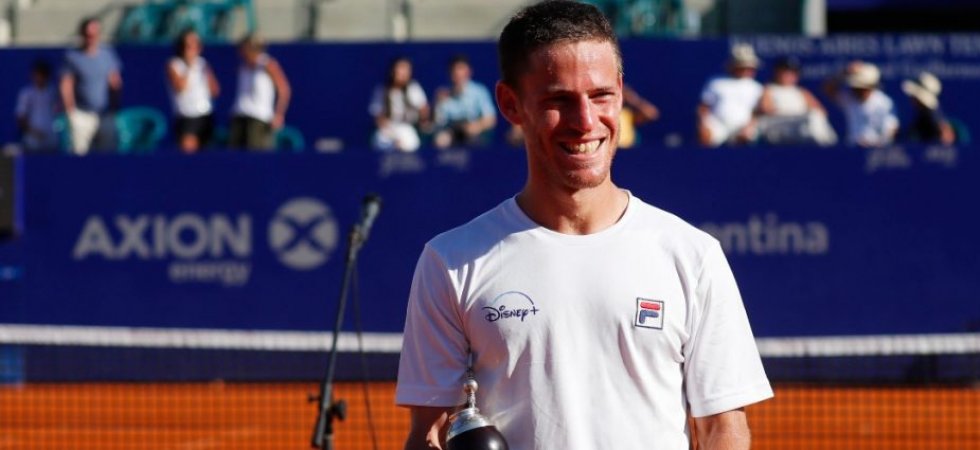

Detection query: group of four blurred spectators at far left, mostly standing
(15, 18), (291, 155)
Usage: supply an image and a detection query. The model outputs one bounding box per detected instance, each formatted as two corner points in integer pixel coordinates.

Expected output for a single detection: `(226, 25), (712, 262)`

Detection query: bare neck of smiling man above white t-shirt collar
(517, 181), (629, 235)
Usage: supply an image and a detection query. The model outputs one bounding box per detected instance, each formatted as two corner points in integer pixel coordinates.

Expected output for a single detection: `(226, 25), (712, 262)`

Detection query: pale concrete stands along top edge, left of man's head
(3, 0), (526, 45)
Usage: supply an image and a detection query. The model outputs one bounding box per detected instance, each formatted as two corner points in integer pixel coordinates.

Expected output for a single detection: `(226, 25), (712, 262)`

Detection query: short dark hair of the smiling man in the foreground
(497, 0), (623, 88)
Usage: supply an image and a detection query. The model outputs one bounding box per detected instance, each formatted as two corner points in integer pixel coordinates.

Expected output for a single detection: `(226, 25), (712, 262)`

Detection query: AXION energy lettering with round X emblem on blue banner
(72, 197), (338, 286)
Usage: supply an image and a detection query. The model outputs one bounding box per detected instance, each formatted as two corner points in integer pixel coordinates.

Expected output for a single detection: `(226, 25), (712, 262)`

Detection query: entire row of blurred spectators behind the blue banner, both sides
(15, 18), (957, 155)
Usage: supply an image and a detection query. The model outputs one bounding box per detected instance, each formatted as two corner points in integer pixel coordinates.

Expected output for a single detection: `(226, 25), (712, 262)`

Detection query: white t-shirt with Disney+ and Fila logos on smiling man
(396, 196), (772, 450)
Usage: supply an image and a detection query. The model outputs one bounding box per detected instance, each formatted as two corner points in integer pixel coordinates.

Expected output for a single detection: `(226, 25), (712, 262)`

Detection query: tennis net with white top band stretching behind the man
(0, 325), (980, 450)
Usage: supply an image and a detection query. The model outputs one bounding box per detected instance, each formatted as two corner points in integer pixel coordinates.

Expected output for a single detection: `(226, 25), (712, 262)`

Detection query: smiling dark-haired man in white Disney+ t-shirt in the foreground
(396, 1), (772, 450)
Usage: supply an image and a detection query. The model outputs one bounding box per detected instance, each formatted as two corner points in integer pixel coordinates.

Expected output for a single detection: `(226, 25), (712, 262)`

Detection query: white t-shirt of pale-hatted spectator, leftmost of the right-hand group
(701, 77), (762, 133)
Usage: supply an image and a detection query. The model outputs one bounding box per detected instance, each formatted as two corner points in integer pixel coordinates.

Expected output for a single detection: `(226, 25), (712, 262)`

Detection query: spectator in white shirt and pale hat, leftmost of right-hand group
(698, 44), (762, 147)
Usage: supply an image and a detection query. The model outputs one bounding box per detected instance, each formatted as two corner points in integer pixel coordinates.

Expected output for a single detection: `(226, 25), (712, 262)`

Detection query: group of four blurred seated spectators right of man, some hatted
(698, 44), (956, 148)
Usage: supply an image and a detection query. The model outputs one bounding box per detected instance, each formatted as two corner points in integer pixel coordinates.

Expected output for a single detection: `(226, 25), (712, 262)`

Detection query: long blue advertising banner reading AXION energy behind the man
(0, 148), (980, 336)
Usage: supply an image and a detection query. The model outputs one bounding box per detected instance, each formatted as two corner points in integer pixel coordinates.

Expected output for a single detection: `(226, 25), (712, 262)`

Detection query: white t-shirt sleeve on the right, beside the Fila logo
(684, 243), (773, 417)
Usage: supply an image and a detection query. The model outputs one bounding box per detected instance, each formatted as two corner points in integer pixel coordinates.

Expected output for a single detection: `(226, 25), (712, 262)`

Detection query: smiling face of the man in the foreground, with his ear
(497, 41), (623, 192)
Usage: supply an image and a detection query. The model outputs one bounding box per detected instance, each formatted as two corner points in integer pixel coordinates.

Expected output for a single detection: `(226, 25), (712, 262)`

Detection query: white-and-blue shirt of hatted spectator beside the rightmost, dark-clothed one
(838, 89), (898, 146)
